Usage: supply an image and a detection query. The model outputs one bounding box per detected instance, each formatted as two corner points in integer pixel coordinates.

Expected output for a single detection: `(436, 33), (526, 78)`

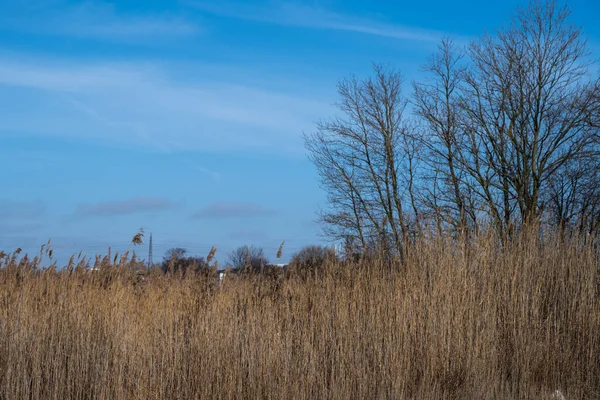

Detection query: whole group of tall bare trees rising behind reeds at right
(305, 0), (600, 256)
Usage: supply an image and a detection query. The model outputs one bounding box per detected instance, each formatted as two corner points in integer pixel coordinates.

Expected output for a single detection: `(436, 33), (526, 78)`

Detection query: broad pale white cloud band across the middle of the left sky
(0, 54), (334, 155)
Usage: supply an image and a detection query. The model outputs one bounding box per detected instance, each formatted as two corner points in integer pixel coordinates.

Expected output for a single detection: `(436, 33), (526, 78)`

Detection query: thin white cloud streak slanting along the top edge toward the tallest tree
(185, 0), (454, 42)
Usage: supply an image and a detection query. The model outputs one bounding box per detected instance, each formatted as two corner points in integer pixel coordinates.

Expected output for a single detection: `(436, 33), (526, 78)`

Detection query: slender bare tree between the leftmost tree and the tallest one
(413, 39), (477, 233)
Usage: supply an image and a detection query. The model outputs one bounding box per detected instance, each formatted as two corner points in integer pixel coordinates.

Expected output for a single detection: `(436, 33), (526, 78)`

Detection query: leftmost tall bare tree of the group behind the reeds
(305, 65), (417, 256)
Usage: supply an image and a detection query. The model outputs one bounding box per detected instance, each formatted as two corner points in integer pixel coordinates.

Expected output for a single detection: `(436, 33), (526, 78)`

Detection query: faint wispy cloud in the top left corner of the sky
(0, 1), (202, 42)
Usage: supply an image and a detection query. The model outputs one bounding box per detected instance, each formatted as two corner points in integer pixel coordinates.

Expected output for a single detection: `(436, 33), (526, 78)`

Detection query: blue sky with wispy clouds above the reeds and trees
(0, 0), (600, 268)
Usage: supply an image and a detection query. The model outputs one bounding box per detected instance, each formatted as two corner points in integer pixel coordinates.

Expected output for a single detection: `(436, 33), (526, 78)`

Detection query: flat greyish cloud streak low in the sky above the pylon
(75, 196), (174, 217)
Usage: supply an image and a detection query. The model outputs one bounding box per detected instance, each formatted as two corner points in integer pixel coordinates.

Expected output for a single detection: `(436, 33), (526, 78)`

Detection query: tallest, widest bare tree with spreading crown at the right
(460, 1), (597, 233)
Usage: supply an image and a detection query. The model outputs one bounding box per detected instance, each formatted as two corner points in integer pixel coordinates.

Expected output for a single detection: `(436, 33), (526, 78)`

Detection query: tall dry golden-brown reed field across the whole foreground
(0, 227), (600, 399)
